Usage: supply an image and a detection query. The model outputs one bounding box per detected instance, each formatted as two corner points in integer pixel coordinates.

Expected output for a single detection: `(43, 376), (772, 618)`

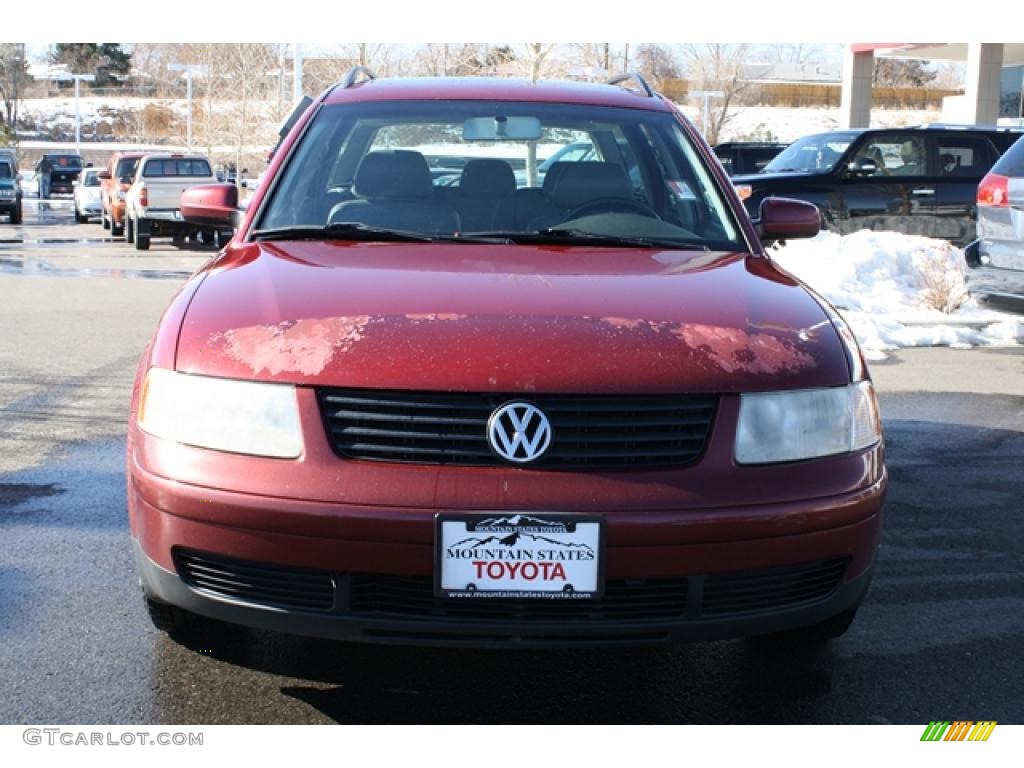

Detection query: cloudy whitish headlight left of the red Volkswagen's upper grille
(138, 368), (302, 459)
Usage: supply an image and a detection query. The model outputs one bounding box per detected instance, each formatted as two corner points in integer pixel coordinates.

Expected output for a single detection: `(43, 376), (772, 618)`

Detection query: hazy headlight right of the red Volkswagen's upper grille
(736, 381), (882, 464)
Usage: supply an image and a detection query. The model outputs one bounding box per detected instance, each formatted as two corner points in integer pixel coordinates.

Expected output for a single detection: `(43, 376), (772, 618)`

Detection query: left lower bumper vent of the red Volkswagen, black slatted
(174, 549), (335, 610)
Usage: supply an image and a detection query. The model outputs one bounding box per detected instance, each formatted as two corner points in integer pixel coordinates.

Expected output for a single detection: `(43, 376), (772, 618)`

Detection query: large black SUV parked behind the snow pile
(733, 125), (1021, 245)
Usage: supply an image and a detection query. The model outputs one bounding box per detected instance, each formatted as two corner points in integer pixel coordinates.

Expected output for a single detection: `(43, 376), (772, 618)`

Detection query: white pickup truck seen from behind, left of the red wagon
(125, 154), (232, 251)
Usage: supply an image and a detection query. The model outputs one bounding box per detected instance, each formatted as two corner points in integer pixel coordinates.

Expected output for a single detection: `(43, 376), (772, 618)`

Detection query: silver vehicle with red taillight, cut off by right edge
(966, 138), (1024, 311)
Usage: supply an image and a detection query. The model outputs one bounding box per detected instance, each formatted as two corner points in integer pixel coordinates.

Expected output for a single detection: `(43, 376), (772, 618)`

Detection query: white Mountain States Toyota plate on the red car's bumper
(434, 513), (604, 600)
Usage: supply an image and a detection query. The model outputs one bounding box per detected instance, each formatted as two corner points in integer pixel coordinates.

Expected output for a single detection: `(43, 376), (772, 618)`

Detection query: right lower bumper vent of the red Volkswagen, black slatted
(701, 558), (848, 615)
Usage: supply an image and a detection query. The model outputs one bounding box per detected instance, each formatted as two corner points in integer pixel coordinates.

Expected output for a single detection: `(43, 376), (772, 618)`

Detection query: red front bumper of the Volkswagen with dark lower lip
(129, 450), (886, 647)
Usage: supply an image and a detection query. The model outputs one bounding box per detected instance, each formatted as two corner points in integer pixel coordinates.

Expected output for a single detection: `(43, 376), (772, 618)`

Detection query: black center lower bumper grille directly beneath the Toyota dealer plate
(350, 573), (686, 622)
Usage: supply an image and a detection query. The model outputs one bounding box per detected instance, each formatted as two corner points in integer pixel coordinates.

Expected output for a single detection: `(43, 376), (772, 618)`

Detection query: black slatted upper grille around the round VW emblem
(317, 389), (718, 468)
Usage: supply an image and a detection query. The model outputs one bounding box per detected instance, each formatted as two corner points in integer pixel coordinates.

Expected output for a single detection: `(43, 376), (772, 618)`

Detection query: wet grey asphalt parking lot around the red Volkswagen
(0, 201), (1024, 724)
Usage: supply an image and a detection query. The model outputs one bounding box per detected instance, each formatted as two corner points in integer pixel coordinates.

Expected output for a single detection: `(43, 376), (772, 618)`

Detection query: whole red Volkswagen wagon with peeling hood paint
(127, 70), (886, 645)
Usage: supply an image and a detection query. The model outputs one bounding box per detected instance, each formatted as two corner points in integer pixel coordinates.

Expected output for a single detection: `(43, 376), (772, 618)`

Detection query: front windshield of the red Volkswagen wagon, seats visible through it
(256, 100), (745, 250)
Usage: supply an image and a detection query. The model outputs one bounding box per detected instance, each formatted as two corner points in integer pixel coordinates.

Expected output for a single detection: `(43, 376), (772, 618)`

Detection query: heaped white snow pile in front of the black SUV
(771, 229), (1024, 360)
